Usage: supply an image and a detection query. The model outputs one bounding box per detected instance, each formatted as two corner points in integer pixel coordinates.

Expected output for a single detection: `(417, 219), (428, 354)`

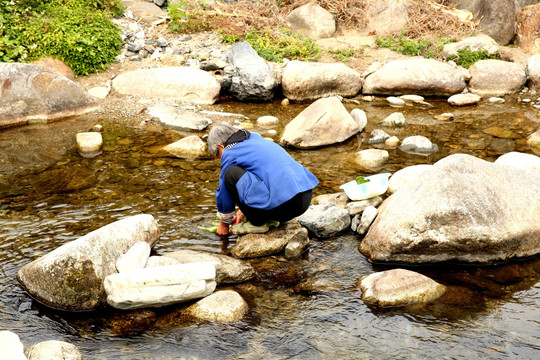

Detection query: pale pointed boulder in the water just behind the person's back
(281, 96), (359, 148)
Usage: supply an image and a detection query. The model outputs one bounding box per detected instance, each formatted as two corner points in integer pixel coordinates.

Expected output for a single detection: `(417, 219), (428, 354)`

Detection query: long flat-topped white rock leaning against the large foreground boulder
(103, 263), (216, 309)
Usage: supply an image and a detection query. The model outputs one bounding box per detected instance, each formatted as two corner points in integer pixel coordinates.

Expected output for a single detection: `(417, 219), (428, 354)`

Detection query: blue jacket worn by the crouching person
(216, 133), (319, 214)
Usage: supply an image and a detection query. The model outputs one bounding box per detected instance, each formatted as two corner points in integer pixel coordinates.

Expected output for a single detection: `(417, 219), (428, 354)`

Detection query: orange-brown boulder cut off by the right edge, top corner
(516, 4), (540, 55)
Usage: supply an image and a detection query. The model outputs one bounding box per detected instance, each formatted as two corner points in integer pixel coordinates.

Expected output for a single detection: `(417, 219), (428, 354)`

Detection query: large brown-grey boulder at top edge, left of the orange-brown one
(474, 0), (516, 45)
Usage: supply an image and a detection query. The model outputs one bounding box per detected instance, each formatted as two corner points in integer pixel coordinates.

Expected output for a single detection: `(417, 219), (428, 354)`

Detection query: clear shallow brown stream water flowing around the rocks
(0, 94), (540, 359)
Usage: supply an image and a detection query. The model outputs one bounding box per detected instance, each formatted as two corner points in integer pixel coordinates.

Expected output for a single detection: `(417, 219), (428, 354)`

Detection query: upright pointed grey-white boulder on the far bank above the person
(227, 41), (278, 101)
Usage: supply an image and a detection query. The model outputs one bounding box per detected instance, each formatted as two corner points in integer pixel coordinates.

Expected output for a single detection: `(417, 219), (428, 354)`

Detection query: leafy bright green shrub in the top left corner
(0, 0), (122, 75)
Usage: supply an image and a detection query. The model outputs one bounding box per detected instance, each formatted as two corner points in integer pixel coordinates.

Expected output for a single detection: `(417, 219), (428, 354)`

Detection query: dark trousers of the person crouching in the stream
(225, 165), (312, 226)
